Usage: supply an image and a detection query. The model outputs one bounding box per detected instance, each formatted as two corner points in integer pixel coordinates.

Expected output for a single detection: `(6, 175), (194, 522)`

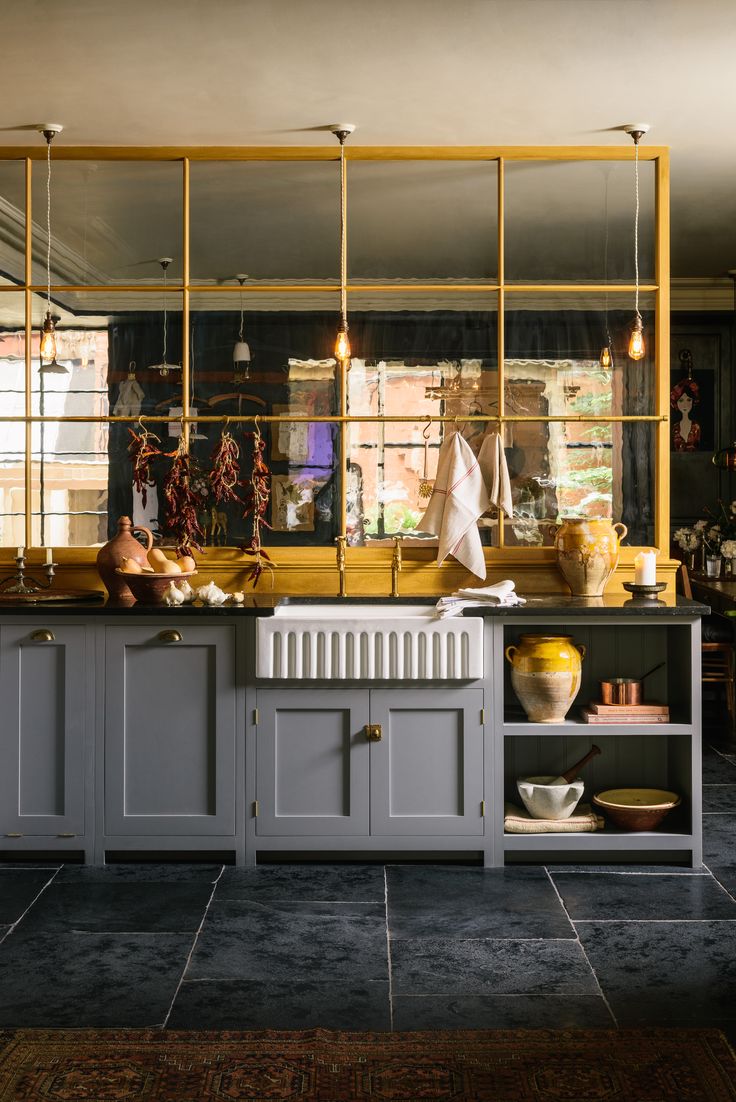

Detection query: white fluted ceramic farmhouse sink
(256, 599), (484, 681)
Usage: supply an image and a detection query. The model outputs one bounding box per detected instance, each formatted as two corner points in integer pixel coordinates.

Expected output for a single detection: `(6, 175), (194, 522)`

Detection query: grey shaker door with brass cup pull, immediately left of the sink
(105, 624), (236, 840)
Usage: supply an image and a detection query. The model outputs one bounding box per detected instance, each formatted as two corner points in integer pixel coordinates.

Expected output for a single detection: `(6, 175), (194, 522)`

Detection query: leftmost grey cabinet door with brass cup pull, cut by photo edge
(0, 620), (88, 852)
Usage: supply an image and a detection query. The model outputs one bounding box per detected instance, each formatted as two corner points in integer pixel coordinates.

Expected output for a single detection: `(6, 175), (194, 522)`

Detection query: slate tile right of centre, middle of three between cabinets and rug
(391, 939), (598, 996)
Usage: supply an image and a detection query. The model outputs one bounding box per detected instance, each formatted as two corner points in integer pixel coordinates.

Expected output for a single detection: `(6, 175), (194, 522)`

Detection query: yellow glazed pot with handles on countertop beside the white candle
(553, 517), (628, 597)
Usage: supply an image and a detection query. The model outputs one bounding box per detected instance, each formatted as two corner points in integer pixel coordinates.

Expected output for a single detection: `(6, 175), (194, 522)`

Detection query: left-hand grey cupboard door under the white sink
(257, 689), (369, 835)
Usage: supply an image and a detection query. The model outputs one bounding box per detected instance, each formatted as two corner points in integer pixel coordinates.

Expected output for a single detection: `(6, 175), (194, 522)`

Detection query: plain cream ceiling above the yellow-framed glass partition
(0, 0), (736, 278)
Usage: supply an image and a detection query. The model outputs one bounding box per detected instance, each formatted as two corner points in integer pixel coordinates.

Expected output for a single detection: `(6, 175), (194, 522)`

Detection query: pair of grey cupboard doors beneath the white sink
(256, 688), (484, 849)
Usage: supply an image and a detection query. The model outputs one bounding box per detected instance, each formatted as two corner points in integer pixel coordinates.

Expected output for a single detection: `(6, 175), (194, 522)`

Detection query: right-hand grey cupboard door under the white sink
(370, 689), (484, 835)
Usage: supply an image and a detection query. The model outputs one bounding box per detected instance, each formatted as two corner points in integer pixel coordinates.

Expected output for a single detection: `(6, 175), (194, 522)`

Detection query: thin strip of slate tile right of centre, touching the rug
(393, 995), (615, 1030)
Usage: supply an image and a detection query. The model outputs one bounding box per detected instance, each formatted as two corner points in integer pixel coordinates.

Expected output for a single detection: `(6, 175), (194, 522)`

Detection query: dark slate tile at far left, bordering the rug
(0, 933), (192, 1028)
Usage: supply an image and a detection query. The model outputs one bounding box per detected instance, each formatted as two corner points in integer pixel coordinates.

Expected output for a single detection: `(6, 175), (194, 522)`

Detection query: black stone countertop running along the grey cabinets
(0, 593), (710, 619)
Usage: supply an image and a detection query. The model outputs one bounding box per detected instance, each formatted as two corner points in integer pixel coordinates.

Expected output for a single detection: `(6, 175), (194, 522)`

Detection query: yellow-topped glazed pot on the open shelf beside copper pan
(506, 635), (585, 723)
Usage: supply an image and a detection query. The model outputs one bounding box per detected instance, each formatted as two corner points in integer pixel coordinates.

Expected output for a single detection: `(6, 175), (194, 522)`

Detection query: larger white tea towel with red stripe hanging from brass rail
(419, 432), (488, 577)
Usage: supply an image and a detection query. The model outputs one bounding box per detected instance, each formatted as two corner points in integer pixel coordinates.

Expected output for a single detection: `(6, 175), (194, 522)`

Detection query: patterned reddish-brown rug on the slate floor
(0, 1029), (736, 1102)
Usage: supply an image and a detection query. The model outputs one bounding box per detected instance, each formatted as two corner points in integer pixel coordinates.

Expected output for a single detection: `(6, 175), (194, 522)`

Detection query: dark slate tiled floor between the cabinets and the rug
(0, 746), (736, 1040)
